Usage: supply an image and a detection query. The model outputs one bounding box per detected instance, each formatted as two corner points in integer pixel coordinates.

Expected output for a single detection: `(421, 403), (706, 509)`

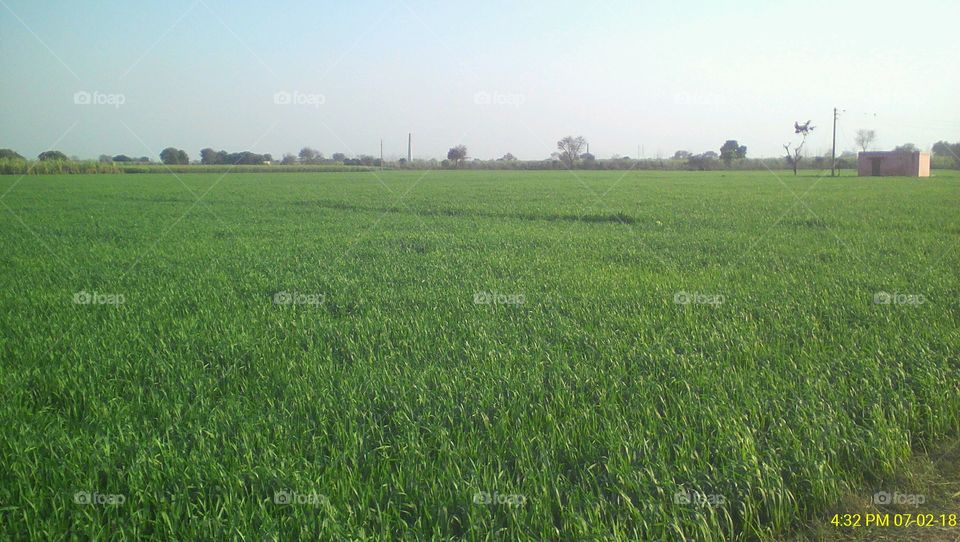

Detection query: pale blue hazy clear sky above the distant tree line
(0, 0), (960, 159)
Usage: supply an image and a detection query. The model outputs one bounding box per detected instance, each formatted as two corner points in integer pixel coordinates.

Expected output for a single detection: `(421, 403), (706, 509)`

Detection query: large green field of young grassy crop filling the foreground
(0, 171), (960, 540)
